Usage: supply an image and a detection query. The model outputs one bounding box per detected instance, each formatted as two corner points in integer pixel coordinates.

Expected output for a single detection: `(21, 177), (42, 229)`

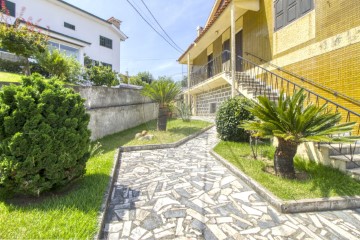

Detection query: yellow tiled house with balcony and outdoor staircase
(179, 0), (360, 116)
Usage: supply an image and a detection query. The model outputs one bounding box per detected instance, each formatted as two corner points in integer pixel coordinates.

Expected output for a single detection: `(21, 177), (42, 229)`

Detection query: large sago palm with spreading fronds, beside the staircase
(241, 89), (356, 178)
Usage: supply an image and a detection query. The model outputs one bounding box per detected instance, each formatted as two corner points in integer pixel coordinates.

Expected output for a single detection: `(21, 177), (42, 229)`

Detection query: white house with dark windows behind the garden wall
(0, 0), (127, 72)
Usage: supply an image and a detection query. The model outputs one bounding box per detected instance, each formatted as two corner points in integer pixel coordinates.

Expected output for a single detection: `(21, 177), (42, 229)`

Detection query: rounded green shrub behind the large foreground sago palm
(215, 97), (254, 142)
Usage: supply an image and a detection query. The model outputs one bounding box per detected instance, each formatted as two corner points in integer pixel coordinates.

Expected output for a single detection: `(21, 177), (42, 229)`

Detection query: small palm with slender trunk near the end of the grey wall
(141, 79), (181, 131)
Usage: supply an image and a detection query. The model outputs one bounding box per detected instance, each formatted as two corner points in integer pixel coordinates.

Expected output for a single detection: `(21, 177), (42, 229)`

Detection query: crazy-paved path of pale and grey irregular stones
(104, 128), (360, 240)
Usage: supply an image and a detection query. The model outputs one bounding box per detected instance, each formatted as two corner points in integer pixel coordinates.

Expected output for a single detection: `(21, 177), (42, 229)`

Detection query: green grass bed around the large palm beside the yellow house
(214, 141), (360, 200)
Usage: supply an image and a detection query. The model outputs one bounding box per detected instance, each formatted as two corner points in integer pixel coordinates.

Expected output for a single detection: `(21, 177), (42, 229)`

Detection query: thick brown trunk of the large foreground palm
(274, 138), (298, 179)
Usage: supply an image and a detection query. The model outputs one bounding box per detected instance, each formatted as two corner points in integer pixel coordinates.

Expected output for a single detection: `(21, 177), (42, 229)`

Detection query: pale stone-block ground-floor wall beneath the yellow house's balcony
(196, 84), (231, 116)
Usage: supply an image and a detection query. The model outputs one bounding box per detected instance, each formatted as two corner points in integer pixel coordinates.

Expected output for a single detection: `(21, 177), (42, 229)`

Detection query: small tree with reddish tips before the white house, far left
(0, 10), (48, 75)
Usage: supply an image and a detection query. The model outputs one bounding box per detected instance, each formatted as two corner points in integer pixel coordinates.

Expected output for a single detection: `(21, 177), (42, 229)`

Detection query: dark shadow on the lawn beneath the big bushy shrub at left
(0, 173), (109, 212)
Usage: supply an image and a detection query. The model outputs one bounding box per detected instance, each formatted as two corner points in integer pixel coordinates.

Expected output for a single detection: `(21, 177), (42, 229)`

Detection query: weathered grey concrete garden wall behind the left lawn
(74, 87), (157, 140)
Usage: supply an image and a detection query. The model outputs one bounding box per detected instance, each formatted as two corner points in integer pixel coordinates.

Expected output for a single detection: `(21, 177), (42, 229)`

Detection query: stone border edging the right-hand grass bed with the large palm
(210, 150), (360, 213)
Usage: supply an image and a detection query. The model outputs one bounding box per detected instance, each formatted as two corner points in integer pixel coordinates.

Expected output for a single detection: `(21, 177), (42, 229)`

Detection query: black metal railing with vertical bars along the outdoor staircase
(237, 53), (360, 162)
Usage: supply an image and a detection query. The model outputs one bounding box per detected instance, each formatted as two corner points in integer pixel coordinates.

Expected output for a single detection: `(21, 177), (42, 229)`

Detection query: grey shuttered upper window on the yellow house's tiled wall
(274, 0), (314, 31)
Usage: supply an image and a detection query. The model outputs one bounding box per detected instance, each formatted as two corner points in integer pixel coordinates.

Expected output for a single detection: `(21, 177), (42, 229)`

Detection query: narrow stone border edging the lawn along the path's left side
(94, 124), (214, 239)
